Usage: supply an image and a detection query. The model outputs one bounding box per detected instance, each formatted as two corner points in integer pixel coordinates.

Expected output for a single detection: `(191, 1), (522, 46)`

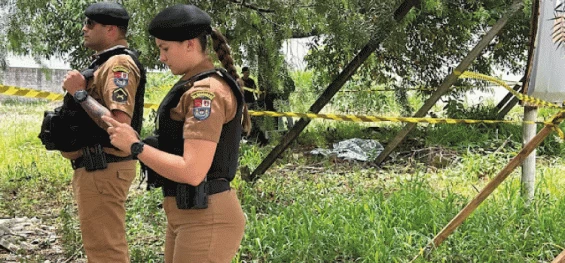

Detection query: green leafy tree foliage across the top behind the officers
(0, 0), (531, 110)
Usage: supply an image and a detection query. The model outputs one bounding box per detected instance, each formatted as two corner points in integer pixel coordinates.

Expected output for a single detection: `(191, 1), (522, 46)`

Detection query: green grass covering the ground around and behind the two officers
(0, 76), (565, 263)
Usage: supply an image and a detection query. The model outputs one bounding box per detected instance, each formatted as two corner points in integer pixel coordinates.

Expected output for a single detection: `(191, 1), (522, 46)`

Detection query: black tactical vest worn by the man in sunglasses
(39, 47), (146, 152)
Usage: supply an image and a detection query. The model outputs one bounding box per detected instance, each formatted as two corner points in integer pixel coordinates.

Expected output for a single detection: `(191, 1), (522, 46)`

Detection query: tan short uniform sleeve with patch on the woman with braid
(171, 78), (237, 143)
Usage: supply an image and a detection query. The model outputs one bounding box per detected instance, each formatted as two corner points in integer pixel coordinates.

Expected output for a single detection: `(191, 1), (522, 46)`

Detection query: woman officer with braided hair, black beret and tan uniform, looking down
(104, 4), (249, 262)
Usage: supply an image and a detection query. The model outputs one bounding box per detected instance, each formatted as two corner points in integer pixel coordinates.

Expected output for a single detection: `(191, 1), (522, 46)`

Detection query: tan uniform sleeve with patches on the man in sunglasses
(100, 55), (140, 118)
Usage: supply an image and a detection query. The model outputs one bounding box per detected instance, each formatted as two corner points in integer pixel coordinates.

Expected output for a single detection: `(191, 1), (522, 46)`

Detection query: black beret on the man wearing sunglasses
(84, 2), (129, 26)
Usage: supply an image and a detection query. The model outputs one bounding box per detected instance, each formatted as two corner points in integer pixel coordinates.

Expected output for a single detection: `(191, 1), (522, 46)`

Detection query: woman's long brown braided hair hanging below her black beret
(198, 29), (251, 135)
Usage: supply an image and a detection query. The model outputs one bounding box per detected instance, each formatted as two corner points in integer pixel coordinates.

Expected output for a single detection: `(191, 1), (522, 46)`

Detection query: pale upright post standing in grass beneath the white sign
(521, 106), (538, 203)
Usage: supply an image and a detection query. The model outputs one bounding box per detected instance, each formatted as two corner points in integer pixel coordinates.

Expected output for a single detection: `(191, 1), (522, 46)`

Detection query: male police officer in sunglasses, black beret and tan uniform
(62, 2), (145, 263)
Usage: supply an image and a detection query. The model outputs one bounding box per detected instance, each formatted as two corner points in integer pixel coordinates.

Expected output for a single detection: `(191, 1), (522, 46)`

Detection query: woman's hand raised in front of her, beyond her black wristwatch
(102, 116), (140, 154)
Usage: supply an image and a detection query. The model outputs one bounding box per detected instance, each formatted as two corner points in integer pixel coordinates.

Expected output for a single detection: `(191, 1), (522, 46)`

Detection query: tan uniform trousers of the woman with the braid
(163, 189), (245, 263)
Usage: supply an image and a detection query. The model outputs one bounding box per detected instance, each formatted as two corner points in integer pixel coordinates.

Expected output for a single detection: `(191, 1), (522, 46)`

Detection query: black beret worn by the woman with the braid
(149, 4), (212, 41)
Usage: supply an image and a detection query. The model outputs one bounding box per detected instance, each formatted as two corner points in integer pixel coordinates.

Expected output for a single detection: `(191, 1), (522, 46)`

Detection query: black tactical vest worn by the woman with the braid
(155, 69), (243, 196)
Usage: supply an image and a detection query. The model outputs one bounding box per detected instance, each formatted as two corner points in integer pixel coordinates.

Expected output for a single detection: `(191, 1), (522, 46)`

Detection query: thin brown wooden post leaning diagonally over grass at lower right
(414, 111), (565, 259)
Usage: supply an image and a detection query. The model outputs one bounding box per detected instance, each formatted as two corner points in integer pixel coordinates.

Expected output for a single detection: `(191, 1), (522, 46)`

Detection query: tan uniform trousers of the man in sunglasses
(72, 160), (136, 263)
